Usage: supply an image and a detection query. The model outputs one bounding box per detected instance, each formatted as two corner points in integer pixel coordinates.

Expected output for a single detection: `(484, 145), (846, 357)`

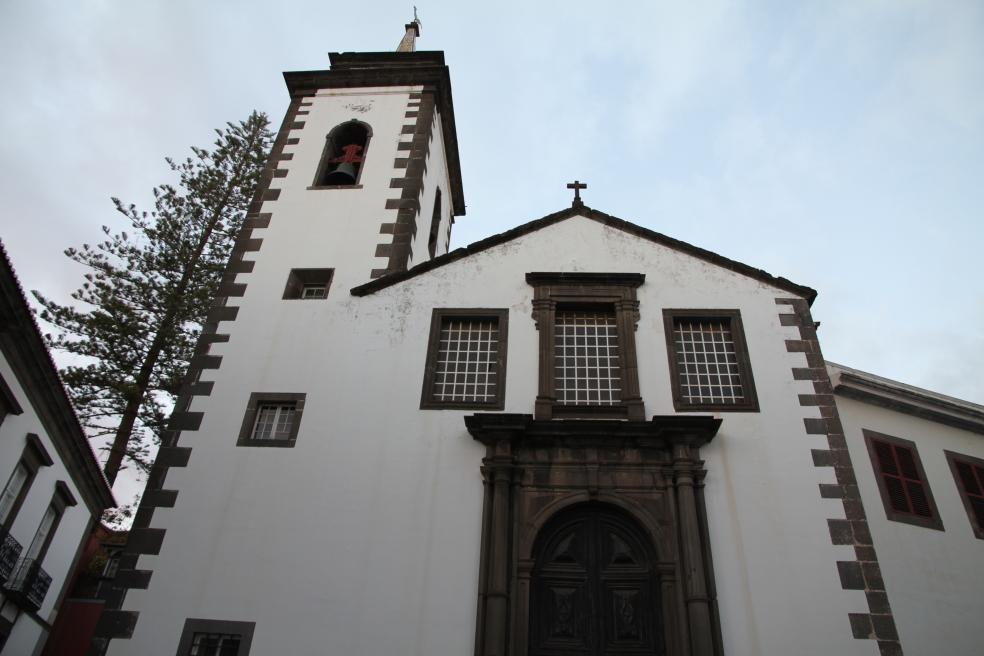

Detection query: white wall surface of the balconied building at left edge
(0, 355), (92, 654)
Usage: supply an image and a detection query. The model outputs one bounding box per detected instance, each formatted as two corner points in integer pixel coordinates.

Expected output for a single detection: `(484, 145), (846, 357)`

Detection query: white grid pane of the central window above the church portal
(554, 311), (622, 405)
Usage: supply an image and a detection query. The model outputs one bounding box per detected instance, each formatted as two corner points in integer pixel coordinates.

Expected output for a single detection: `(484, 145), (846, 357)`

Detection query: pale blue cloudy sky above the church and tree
(0, 0), (984, 498)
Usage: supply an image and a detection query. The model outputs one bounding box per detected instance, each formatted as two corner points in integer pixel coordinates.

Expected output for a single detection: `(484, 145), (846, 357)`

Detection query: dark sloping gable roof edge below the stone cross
(351, 204), (817, 305)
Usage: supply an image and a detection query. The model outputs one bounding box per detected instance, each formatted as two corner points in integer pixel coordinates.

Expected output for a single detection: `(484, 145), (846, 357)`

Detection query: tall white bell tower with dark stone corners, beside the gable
(97, 18), (465, 656)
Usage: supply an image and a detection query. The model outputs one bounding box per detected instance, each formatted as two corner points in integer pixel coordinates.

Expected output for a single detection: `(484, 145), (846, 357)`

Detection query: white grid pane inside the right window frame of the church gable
(673, 319), (745, 405)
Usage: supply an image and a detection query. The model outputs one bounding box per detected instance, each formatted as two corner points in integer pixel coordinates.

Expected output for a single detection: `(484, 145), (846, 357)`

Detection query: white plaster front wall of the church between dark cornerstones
(110, 217), (877, 656)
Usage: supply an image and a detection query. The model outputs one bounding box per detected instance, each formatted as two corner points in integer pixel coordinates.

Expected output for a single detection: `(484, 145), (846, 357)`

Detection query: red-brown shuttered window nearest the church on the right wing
(864, 430), (943, 530)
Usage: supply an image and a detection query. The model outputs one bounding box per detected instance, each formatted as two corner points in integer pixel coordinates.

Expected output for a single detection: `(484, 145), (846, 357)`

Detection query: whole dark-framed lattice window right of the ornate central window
(663, 310), (758, 411)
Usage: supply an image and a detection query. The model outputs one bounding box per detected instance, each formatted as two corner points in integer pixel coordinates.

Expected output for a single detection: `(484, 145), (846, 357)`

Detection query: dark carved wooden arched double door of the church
(529, 504), (664, 656)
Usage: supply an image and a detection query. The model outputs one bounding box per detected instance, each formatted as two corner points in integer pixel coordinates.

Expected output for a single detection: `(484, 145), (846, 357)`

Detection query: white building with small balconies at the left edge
(0, 247), (116, 656)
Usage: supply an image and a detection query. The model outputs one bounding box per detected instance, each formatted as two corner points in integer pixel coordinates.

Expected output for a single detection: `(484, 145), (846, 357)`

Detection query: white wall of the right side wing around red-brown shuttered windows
(837, 396), (984, 656)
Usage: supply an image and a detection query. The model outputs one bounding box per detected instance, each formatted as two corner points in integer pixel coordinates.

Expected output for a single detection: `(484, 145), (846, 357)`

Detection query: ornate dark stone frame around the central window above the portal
(526, 272), (646, 421)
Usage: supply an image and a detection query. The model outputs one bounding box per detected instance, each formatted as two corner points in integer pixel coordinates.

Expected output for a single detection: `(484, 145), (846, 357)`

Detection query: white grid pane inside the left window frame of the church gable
(432, 319), (499, 403)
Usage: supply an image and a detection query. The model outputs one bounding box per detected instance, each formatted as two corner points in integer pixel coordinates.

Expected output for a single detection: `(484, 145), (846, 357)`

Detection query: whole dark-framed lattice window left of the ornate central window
(420, 308), (508, 409)
